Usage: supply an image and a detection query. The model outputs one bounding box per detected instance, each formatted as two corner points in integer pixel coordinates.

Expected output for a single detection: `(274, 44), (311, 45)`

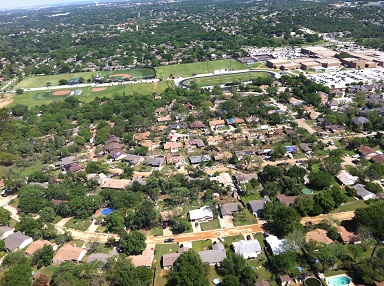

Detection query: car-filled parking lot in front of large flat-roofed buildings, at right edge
(308, 68), (384, 88)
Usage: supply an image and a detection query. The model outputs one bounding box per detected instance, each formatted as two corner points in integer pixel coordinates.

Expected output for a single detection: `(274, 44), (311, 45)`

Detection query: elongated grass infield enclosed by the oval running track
(193, 72), (270, 86)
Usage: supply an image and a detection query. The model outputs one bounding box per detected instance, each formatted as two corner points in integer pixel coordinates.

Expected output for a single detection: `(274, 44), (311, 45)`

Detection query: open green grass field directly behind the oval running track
(156, 59), (248, 78)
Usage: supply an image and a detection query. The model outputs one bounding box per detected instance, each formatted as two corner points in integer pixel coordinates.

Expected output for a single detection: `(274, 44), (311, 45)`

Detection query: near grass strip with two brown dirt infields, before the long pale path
(10, 81), (172, 107)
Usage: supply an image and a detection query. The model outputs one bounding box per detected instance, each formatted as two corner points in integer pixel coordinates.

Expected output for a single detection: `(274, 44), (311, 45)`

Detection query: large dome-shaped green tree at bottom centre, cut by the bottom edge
(168, 250), (209, 286)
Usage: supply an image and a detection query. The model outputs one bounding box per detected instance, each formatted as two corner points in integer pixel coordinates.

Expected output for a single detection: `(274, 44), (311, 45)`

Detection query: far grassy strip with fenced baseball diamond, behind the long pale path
(14, 68), (155, 89)
